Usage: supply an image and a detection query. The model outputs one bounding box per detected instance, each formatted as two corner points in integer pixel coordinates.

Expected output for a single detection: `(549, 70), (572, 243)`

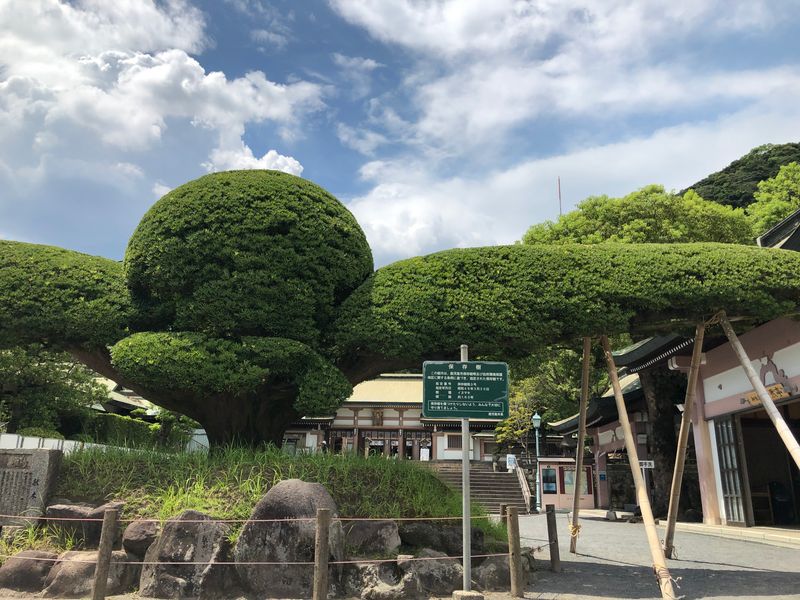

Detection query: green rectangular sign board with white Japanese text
(422, 360), (508, 420)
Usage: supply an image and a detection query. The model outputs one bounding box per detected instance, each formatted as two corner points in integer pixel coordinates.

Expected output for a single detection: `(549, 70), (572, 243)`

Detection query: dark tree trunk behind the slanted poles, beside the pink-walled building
(639, 365), (686, 517)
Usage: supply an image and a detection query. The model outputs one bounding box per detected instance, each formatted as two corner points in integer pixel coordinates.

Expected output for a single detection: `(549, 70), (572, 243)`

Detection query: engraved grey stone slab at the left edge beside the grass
(0, 449), (61, 525)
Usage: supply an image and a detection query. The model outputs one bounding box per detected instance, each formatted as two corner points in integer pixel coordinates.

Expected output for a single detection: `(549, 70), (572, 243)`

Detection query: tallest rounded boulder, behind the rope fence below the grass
(234, 479), (344, 598)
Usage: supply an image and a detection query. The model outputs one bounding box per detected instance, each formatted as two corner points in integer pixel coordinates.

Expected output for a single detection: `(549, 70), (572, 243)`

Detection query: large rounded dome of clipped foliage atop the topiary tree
(125, 171), (372, 346)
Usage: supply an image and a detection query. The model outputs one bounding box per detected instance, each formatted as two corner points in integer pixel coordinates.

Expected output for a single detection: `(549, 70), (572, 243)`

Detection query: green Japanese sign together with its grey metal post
(422, 352), (508, 592)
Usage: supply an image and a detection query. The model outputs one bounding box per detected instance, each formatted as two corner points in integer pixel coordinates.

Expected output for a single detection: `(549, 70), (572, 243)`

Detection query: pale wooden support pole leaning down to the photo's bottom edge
(600, 336), (675, 600)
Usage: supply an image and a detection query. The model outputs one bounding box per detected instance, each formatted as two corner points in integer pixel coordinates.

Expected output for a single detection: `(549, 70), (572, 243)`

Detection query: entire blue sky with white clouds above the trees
(0, 0), (800, 265)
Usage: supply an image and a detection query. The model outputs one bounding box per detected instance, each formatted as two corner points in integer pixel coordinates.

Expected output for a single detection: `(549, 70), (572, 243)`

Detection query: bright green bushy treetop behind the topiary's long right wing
(523, 185), (754, 244)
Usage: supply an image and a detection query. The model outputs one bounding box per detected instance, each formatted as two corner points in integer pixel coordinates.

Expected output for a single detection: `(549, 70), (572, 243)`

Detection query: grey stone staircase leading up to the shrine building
(423, 461), (528, 515)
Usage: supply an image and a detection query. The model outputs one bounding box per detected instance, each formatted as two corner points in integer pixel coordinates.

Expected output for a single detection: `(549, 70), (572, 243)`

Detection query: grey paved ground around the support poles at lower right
(520, 514), (800, 600)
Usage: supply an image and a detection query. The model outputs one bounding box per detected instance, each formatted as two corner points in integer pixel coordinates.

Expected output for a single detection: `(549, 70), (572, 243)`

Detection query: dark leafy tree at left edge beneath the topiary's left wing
(0, 345), (108, 437)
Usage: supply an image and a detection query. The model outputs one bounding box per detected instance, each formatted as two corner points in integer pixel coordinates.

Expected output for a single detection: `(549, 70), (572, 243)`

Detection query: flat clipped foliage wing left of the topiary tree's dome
(0, 240), (131, 347)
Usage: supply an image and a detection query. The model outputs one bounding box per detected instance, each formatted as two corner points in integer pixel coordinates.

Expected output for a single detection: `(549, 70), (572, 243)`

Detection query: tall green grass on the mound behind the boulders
(55, 447), (505, 538)
